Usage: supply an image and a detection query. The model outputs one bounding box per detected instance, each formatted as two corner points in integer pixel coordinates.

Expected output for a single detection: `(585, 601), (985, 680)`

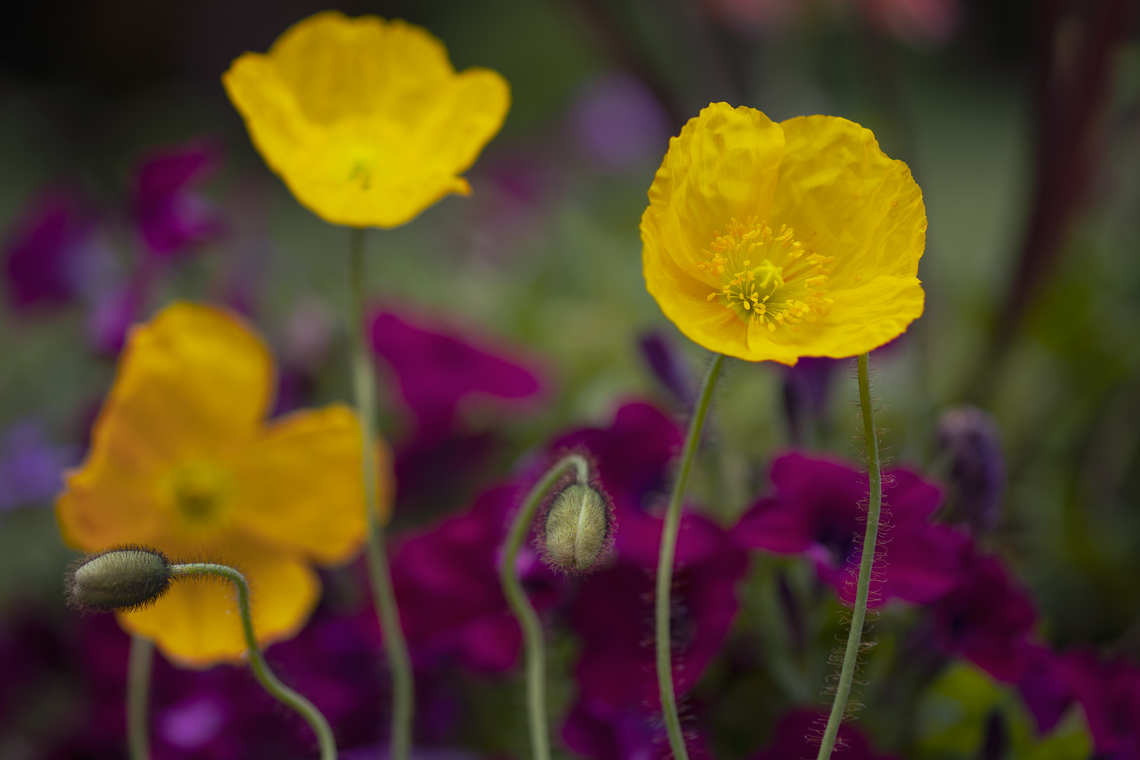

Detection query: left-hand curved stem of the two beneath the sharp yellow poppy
(656, 353), (724, 760)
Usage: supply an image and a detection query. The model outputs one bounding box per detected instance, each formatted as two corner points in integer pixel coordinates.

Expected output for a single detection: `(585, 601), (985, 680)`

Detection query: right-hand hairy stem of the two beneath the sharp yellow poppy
(817, 353), (882, 760)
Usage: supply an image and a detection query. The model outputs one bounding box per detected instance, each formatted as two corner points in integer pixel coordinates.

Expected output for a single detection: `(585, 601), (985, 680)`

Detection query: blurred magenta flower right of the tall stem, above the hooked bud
(372, 311), (543, 439)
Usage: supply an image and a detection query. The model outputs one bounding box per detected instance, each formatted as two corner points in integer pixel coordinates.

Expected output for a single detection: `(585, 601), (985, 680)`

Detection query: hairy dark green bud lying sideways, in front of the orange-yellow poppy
(64, 546), (173, 612)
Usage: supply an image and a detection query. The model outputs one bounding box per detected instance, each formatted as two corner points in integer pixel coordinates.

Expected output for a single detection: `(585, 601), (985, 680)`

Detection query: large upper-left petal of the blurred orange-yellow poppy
(57, 303), (272, 550)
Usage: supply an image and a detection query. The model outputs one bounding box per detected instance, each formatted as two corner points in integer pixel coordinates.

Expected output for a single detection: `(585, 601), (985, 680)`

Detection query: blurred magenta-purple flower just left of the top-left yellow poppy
(131, 141), (222, 258)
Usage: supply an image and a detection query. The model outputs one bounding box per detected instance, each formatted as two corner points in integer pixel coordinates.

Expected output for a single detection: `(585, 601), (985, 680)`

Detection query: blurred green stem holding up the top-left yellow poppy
(349, 228), (415, 760)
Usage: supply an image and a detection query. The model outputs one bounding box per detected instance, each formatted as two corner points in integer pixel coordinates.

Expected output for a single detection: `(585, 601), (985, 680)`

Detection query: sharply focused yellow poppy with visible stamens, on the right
(641, 103), (927, 365)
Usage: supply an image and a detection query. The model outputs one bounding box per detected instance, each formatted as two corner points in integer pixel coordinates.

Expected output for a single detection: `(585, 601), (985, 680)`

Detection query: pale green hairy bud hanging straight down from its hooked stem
(543, 481), (613, 573)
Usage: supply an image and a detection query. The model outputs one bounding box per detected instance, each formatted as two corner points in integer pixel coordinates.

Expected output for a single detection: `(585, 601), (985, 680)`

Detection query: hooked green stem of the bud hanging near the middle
(499, 453), (589, 760)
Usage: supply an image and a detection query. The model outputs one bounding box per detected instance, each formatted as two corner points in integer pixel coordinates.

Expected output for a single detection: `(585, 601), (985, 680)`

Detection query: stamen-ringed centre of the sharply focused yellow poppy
(697, 216), (836, 333)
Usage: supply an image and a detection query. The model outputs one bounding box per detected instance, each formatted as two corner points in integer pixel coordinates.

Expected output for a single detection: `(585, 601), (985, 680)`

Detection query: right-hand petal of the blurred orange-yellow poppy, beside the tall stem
(234, 404), (365, 563)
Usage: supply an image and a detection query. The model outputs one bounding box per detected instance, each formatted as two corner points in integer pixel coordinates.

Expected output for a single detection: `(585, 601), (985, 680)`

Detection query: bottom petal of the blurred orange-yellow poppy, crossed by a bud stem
(117, 534), (320, 668)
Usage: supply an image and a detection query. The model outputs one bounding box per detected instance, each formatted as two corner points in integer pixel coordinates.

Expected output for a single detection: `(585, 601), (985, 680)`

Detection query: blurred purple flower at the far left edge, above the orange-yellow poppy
(3, 187), (96, 310)
